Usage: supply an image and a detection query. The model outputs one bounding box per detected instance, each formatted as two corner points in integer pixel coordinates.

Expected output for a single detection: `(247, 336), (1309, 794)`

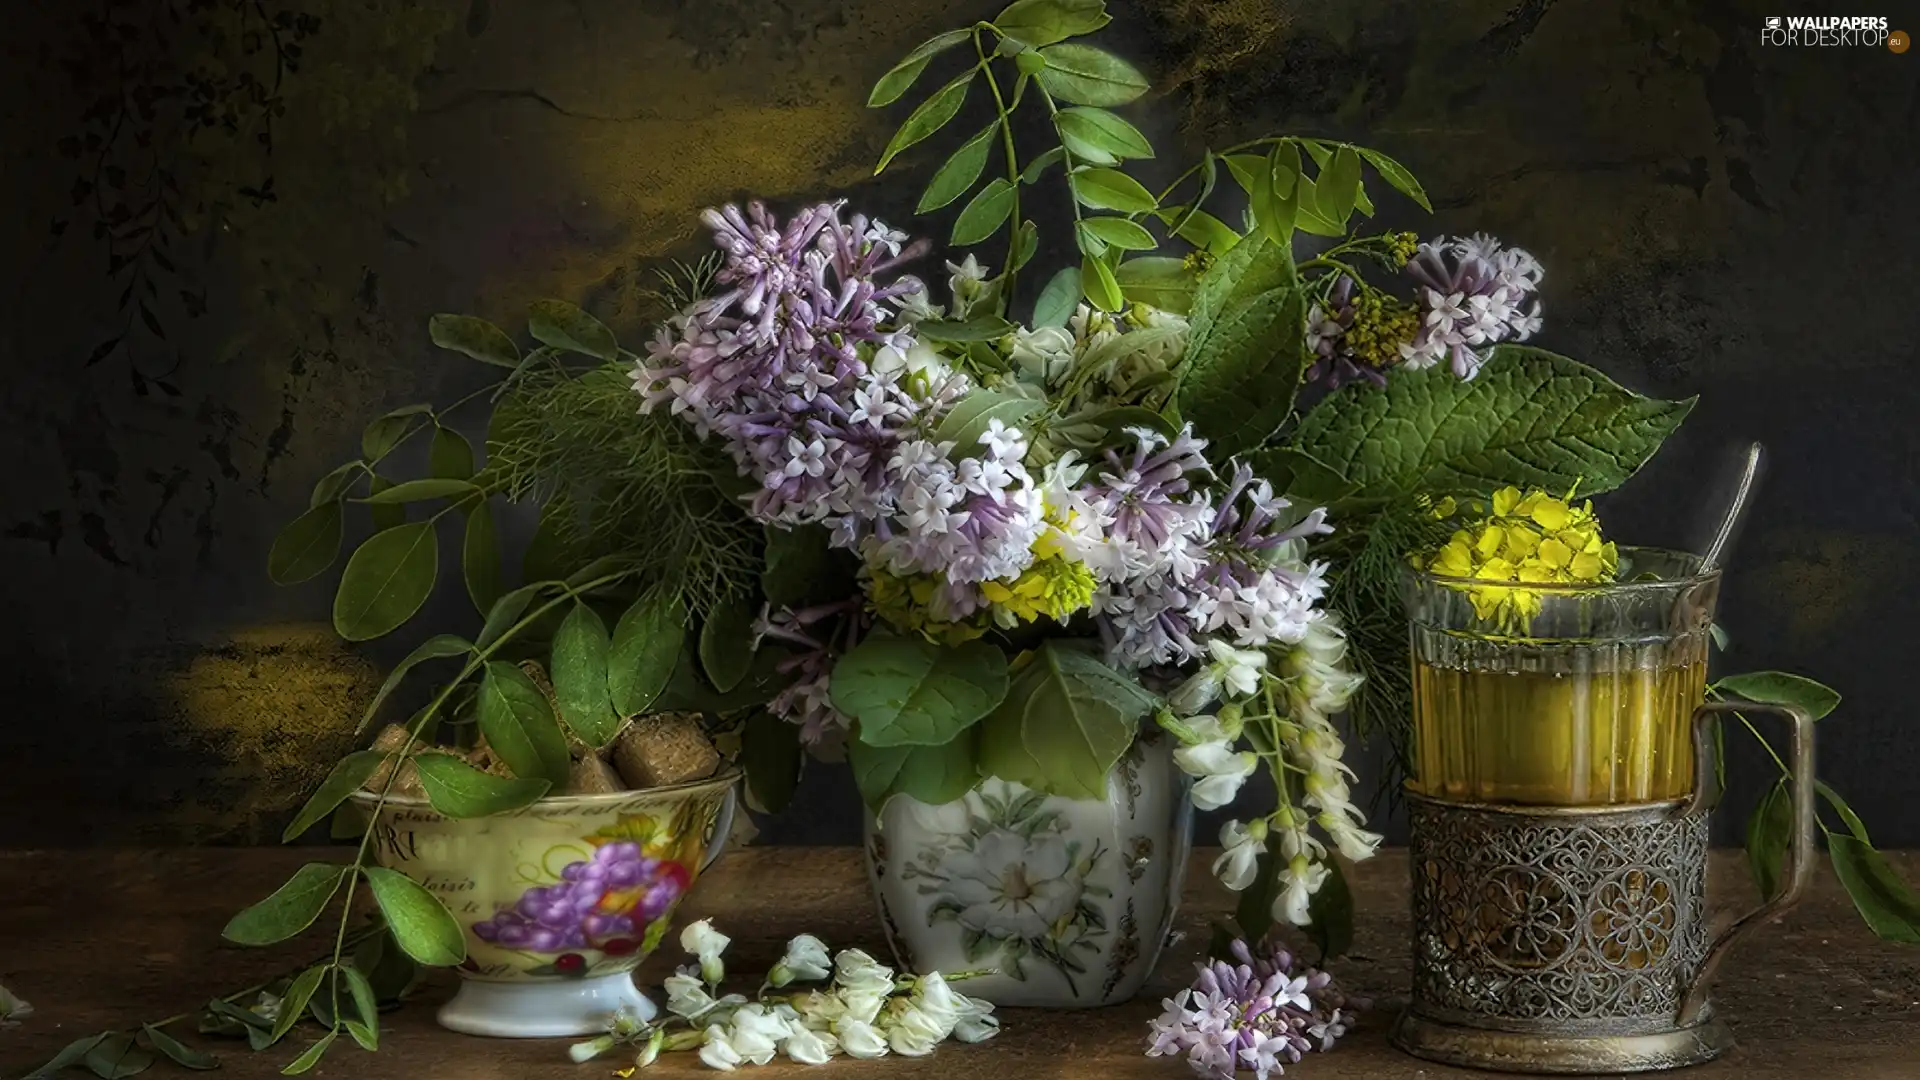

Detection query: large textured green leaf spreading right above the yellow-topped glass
(1294, 346), (1693, 498)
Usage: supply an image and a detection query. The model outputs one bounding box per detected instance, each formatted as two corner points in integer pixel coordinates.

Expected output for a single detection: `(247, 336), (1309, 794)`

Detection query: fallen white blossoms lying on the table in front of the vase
(566, 919), (1000, 1074)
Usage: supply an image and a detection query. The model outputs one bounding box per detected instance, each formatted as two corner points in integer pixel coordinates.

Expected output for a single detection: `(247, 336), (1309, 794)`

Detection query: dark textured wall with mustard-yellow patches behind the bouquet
(0, 0), (1920, 846)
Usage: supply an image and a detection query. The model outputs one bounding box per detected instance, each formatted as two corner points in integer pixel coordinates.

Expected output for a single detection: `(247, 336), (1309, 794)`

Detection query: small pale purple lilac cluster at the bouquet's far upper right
(1400, 233), (1546, 379)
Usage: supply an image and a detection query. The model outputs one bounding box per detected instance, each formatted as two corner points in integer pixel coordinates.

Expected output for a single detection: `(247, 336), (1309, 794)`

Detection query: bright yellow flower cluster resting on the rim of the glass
(1413, 488), (1620, 623)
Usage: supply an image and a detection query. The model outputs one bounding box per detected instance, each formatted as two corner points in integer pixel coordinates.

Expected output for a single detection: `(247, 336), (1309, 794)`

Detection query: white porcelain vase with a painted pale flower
(866, 732), (1192, 1009)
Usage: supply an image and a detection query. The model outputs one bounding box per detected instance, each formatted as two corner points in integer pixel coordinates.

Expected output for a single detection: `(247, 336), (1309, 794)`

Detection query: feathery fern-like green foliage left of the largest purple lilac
(486, 363), (762, 613)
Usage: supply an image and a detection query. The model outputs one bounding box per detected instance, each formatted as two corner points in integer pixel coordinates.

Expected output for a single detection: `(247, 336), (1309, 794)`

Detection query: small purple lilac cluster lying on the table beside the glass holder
(1146, 942), (1359, 1080)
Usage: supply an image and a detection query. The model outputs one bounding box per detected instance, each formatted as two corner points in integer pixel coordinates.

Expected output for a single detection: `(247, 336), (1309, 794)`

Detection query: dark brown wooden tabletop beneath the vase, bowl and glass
(0, 847), (1920, 1080)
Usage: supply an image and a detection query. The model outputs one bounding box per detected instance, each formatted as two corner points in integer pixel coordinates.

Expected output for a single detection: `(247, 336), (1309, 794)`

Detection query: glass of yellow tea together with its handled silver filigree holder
(1392, 552), (1814, 1072)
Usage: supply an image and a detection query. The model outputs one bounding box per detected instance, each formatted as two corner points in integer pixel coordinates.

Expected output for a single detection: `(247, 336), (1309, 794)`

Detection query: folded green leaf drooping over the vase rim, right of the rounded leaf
(979, 640), (1156, 799)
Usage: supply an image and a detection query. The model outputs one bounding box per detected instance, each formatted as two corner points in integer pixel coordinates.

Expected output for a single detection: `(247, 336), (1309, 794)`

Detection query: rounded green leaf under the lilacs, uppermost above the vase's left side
(829, 636), (1006, 746)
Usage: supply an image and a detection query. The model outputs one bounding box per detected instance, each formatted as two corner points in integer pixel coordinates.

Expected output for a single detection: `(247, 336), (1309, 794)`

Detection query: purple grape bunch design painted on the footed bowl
(472, 840), (691, 957)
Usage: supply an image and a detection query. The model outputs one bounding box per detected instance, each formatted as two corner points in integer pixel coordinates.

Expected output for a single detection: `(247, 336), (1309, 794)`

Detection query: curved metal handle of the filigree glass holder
(1678, 701), (1818, 1026)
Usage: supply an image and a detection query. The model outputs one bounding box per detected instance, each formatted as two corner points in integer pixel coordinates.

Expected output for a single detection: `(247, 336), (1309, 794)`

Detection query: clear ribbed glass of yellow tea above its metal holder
(1402, 548), (1720, 807)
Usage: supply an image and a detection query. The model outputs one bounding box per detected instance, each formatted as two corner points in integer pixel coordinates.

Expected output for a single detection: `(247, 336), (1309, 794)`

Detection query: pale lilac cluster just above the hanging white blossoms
(1087, 430), (1331, 669)
